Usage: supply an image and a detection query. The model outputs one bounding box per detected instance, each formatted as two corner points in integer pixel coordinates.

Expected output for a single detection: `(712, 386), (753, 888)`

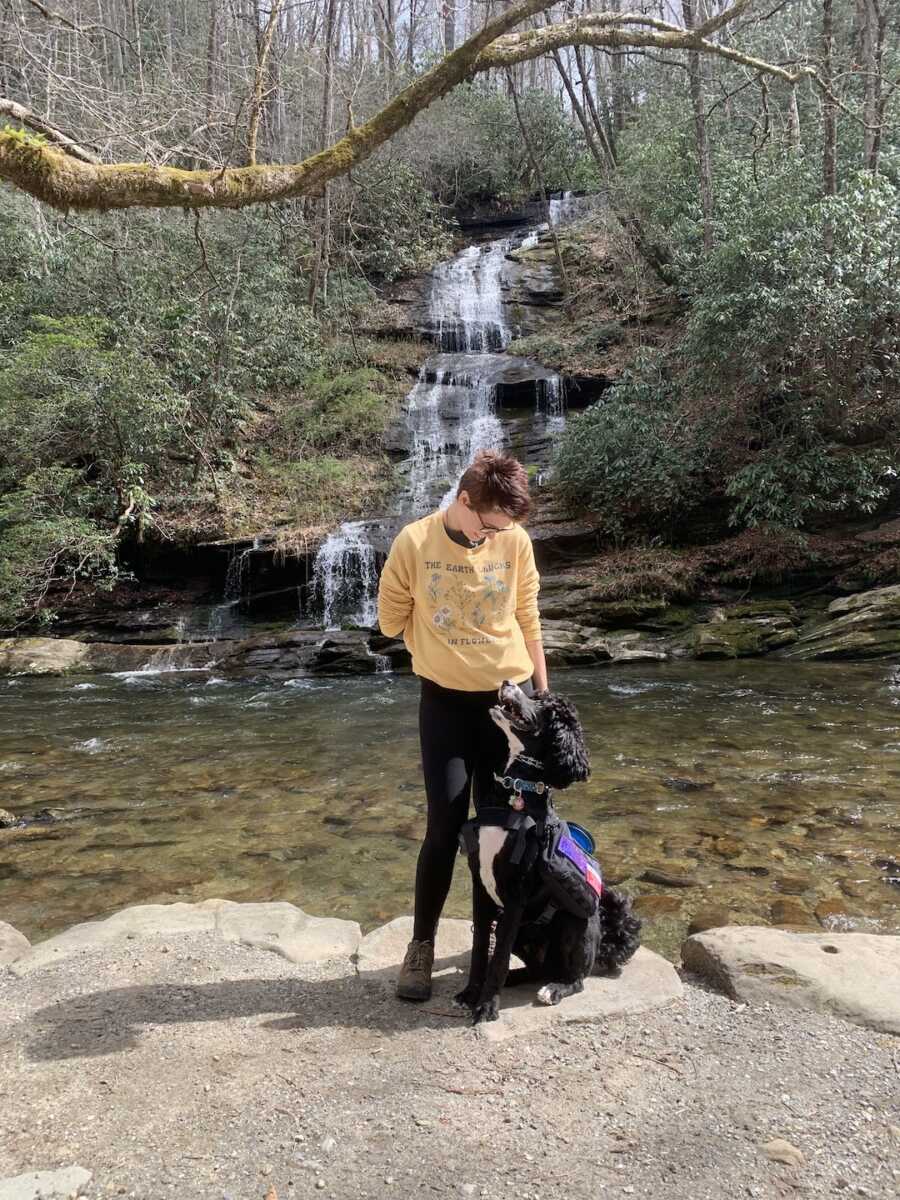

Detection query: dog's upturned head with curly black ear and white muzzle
(491, 679), (590, 788)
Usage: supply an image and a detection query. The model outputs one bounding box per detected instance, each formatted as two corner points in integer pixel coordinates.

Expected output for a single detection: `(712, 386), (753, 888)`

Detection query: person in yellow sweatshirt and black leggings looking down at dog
(378, 450), (547, 1000)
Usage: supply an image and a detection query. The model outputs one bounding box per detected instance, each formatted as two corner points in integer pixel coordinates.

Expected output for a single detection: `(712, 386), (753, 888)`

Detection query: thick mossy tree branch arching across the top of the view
(0, 0), (812, 211)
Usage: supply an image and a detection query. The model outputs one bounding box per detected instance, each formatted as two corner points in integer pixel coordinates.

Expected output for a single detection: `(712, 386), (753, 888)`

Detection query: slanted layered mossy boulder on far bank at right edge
(782, 584), (900, 659)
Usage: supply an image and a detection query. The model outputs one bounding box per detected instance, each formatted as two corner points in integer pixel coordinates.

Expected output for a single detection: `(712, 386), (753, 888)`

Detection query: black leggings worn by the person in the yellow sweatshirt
(413, 679), (534, 941)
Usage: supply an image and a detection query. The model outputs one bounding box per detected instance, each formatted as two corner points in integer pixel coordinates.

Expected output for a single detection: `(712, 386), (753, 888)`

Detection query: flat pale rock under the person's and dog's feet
(356, 917), (683, 1040)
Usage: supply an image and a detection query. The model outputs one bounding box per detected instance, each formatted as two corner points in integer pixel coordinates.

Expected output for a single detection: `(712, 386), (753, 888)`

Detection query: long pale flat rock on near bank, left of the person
(10, 900), (361, 977)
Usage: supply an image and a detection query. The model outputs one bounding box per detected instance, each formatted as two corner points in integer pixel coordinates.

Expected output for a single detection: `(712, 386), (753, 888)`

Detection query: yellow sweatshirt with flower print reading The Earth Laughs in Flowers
(378, 511), (541, 691)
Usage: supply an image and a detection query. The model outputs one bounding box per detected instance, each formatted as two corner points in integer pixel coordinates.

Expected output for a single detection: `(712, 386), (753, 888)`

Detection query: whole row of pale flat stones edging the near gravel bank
(0, 900), (900, 1038)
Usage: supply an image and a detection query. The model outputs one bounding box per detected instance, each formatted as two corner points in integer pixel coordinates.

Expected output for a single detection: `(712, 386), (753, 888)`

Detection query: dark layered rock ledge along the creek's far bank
(0, 575), (900, 679)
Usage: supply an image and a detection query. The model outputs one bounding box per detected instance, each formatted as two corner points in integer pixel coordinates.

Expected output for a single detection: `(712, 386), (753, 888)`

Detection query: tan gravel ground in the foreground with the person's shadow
(0, 935), (900, 1200)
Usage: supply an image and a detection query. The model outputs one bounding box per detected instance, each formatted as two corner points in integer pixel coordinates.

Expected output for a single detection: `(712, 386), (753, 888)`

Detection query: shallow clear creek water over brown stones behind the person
(0, 661), (900, 954)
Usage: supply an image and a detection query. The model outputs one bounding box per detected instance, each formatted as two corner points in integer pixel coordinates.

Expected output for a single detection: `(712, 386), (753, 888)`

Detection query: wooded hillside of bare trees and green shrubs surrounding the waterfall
(0, 0), (900, 629)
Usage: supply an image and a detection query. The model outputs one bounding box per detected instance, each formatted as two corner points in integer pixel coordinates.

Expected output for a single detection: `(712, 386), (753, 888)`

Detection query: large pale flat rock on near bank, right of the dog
(682, 925), (900, 1033)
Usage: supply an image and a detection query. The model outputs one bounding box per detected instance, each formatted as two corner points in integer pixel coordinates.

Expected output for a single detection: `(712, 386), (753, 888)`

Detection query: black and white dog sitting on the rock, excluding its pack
(456, 680), (641, 1024)
